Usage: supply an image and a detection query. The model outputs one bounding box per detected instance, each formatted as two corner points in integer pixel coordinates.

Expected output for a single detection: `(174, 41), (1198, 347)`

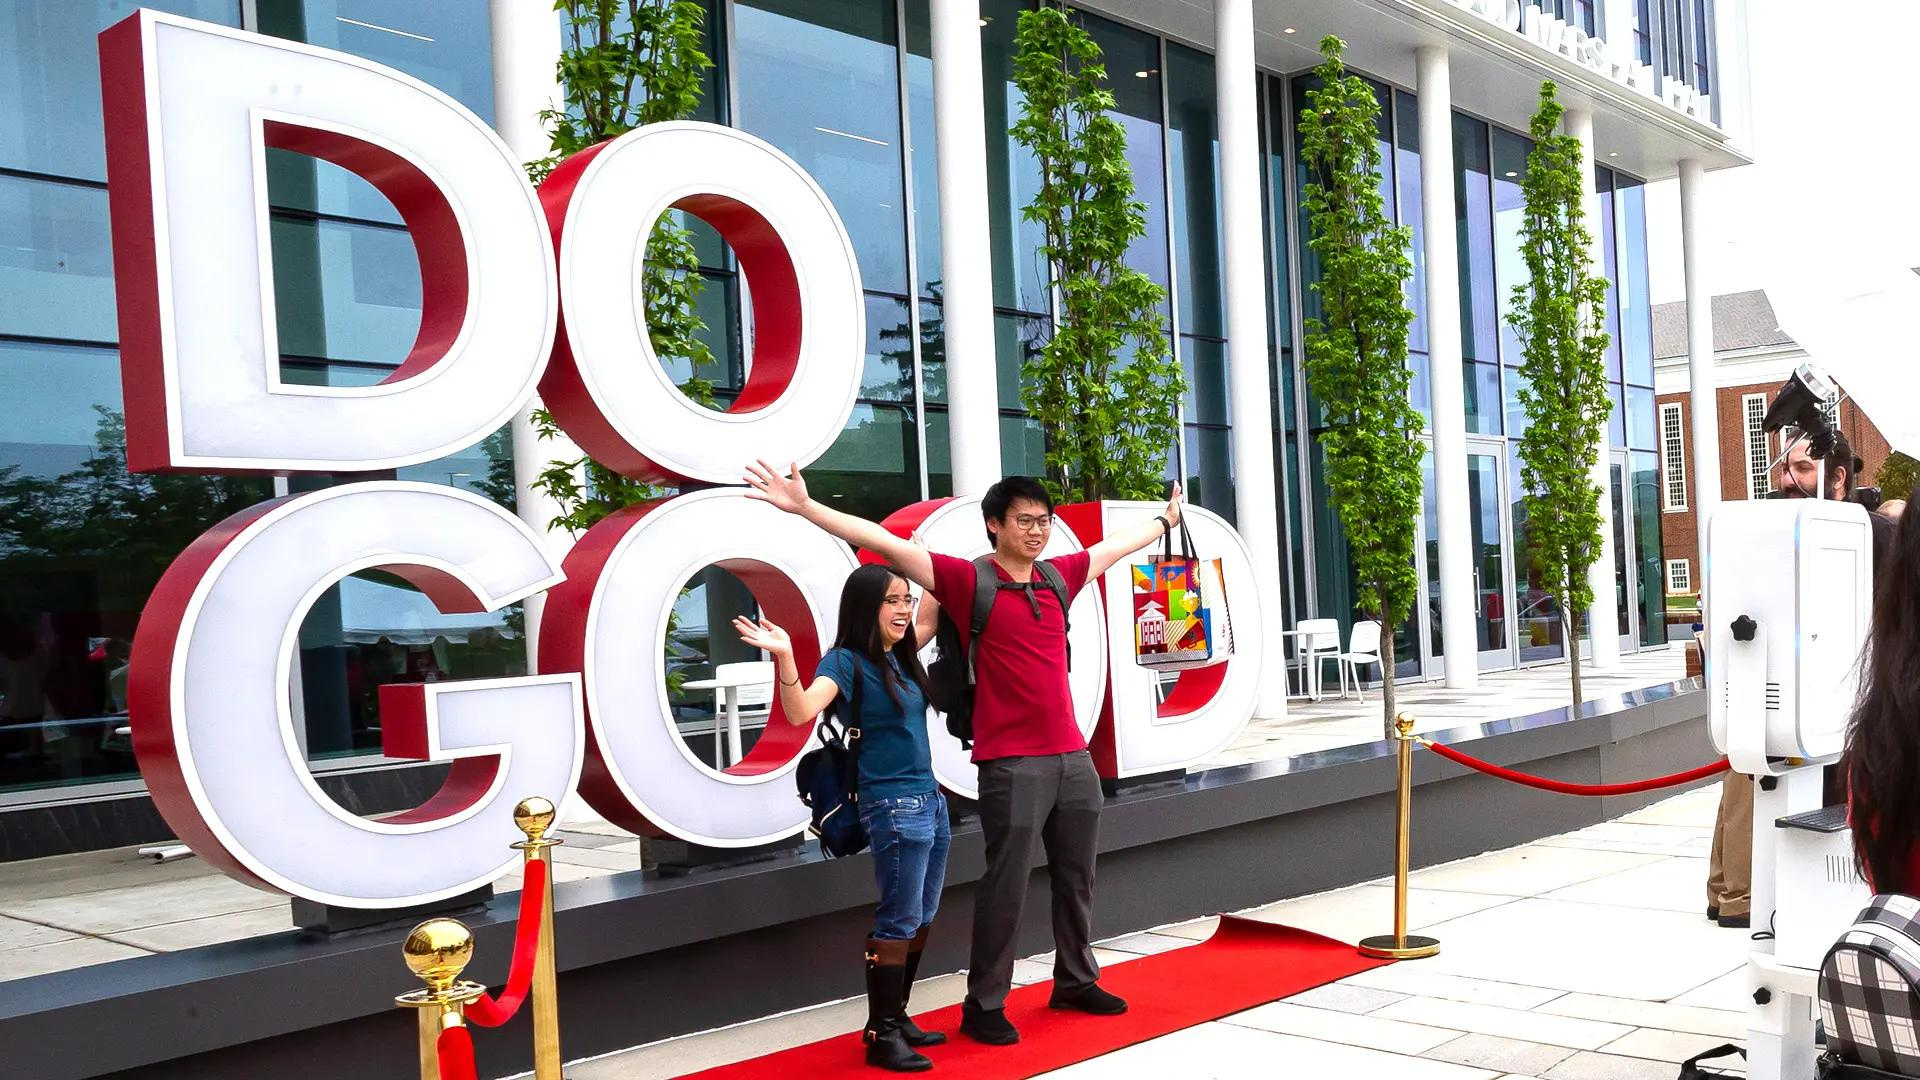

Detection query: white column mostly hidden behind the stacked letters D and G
(488, 0), (580, 671)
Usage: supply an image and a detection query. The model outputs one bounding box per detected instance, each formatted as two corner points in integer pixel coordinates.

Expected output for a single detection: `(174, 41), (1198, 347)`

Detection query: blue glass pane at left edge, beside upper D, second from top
(0, 177), (119, 342)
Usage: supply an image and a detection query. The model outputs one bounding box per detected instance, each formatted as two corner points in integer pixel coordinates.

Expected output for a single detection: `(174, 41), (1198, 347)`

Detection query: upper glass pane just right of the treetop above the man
(1077, 13), (1173, 307)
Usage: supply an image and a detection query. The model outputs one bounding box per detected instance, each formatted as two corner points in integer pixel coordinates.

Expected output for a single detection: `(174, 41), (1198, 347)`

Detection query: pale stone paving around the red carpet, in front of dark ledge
(568, 786), (1747, 1080)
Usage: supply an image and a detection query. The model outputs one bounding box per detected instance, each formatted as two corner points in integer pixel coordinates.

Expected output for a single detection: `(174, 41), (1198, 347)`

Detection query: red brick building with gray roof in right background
(1653, 290), (1889, 607)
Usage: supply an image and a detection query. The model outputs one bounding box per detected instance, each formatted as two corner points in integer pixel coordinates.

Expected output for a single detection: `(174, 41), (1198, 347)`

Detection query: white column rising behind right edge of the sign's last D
(1213, 0), (1286, 719)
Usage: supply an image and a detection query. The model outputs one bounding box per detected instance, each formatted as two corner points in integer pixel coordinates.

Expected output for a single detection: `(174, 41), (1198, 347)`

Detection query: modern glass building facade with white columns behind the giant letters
(0, 0), (1745, 845)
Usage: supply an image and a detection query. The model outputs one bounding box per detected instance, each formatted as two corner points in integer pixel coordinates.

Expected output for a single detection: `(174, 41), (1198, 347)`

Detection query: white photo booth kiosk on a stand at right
(1705, 449), (1872, 1080)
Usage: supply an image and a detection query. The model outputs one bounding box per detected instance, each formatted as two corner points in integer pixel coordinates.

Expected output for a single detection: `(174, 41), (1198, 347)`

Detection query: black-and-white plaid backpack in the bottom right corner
(1820, 894), (1920, 1080)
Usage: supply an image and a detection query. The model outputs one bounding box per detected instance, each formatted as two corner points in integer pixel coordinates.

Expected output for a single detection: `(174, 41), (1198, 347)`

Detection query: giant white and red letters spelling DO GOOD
(100, 10), (1261, 909)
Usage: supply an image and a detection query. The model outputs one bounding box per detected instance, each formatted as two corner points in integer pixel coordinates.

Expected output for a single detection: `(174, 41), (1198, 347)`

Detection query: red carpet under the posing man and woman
(691, 915), (1390, 1080)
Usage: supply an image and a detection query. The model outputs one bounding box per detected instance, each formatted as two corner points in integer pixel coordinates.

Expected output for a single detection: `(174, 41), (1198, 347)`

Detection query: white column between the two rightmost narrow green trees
(1413, 46), (1474, 690)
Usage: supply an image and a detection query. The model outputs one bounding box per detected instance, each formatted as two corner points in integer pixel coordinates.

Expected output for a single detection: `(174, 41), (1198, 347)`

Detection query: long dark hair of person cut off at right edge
(1841, 502), (1920, 892)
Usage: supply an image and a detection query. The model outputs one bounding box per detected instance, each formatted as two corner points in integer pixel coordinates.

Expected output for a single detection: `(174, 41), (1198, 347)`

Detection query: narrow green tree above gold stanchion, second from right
(1300, 37), (1420, 726)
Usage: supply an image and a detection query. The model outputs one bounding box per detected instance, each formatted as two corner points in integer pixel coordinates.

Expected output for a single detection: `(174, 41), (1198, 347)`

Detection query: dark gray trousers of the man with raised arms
(966, 749), (1102, 1009)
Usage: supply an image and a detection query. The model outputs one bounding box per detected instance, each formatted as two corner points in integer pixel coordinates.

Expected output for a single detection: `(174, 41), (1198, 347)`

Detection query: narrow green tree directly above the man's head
(1012, 6), (1185, 502)
